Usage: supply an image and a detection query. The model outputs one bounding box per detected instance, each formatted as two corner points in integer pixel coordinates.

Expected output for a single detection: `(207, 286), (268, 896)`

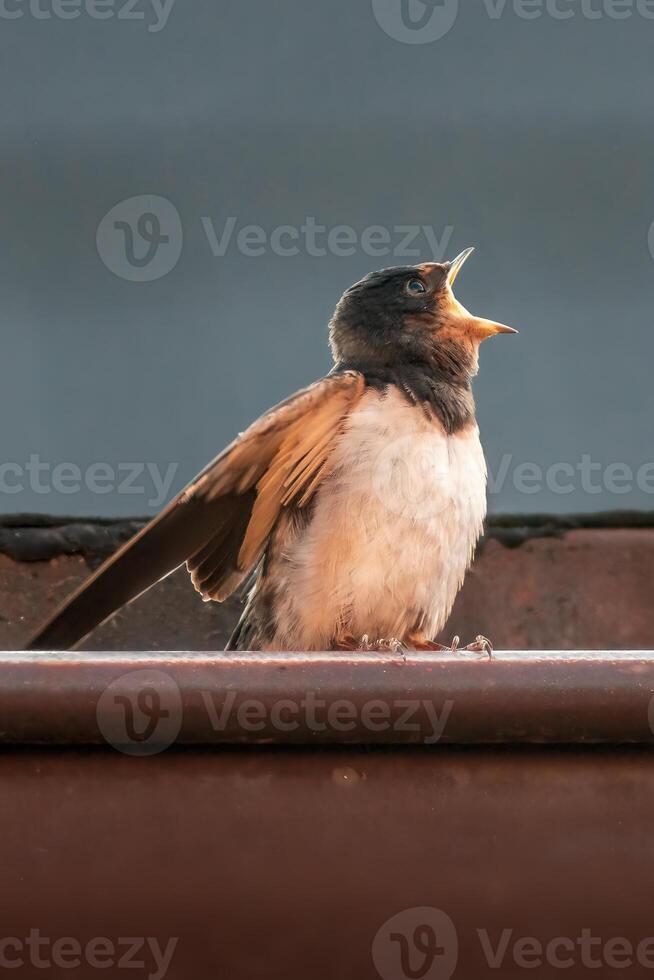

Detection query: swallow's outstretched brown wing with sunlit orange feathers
(26, 371), (364, 650)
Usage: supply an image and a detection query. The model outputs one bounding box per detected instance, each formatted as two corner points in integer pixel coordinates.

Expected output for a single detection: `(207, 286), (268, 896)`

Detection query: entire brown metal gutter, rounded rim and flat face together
(0, 652), (654, 980)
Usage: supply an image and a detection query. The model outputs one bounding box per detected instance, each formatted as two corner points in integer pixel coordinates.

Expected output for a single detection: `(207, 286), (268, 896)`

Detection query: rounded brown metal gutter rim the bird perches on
(0, 651), (654, 755)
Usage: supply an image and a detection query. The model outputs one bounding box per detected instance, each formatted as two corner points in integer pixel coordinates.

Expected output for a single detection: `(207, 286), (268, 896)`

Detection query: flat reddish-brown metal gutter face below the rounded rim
(0, 746), (654, 980)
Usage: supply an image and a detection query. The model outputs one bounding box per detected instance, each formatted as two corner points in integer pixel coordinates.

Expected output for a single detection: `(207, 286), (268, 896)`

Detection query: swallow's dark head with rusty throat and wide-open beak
(330, 248), (517, 377)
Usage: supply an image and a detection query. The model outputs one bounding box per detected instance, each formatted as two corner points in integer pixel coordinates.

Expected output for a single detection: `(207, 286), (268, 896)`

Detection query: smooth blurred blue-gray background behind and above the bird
(0, 0), (654, 516)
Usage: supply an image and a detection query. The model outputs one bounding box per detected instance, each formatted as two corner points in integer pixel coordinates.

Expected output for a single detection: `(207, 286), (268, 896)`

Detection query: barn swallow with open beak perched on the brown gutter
(26, 248), (517, 652)
